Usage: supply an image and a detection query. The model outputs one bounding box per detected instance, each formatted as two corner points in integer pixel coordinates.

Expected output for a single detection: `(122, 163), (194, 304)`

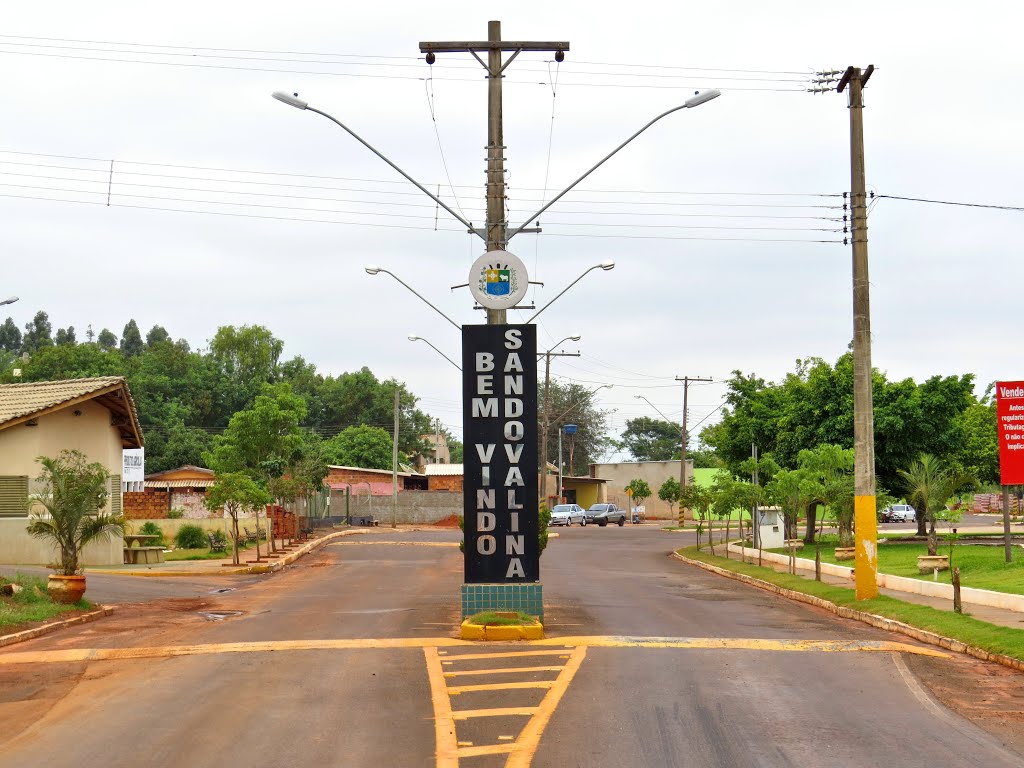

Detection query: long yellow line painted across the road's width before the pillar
(0, 636), (949, 666)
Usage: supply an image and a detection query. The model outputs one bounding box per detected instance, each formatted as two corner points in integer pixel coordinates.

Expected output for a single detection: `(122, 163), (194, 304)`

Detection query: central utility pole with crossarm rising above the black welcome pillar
(420, 22), (569, 326)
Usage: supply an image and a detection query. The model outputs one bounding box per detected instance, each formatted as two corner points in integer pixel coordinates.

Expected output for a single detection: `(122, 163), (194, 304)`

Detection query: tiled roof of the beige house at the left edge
(0, 376), (142, 447)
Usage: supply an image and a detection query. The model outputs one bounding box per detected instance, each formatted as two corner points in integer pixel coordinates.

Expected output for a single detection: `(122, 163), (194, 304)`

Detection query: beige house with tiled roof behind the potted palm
(0, 376), (142, 565)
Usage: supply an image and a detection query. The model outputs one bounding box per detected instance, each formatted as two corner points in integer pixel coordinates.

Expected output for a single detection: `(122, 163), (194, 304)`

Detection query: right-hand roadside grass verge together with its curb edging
(672, 547), (1024, 672)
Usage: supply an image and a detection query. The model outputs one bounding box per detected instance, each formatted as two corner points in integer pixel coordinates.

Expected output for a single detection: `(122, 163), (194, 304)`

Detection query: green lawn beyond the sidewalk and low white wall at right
(771, 537), (1024, 595)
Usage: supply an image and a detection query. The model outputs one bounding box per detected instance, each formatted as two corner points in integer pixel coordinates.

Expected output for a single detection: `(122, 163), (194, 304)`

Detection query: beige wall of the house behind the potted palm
(0, 401), (132, 565)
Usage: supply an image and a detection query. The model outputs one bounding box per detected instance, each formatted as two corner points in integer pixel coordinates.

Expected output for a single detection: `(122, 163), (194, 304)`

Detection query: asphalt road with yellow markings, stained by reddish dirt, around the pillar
(0, 525), (1024, 768)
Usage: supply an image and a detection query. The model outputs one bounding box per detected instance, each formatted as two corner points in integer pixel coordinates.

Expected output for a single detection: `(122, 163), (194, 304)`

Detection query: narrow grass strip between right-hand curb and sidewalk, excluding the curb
(678, 547), (1024, 660)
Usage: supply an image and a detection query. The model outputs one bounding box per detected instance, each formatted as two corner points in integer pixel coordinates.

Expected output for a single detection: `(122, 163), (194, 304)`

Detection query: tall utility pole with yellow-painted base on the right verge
(836, 65), (879, 600)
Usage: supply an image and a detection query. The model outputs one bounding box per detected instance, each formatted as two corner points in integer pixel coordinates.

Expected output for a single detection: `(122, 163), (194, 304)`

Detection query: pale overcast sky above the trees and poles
(0, 0), (1024, 459)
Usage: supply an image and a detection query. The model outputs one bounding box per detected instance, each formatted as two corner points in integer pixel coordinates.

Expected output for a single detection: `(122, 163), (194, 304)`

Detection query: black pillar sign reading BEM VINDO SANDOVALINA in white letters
(462, 326), (541, 585)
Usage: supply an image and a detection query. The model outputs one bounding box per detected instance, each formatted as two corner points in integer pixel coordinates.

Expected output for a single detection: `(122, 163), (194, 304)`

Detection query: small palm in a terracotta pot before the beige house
(28, 451), (125, 603)
